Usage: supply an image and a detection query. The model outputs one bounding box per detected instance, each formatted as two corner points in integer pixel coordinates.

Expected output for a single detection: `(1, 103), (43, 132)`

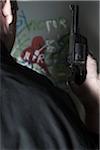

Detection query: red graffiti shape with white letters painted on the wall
(20, 36), (49, 74)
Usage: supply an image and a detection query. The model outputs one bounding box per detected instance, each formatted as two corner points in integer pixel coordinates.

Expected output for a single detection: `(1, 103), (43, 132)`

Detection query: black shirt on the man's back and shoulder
(0, 48), (96, 150)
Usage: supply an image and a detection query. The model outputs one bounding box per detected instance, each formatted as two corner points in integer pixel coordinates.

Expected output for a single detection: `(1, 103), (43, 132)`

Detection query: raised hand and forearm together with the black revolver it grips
(67, 5), (100, 134)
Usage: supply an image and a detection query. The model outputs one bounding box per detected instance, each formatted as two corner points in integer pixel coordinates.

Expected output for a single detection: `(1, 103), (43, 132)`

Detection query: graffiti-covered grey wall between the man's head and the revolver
(11, 1), (70, 87)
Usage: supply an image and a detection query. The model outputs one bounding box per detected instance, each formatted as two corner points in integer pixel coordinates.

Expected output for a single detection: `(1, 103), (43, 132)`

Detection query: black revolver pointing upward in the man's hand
(67, 5), (88, 85)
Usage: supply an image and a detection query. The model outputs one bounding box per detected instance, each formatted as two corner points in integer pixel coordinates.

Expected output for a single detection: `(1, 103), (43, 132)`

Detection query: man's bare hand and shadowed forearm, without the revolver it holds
(71, 55), (100, 133)
